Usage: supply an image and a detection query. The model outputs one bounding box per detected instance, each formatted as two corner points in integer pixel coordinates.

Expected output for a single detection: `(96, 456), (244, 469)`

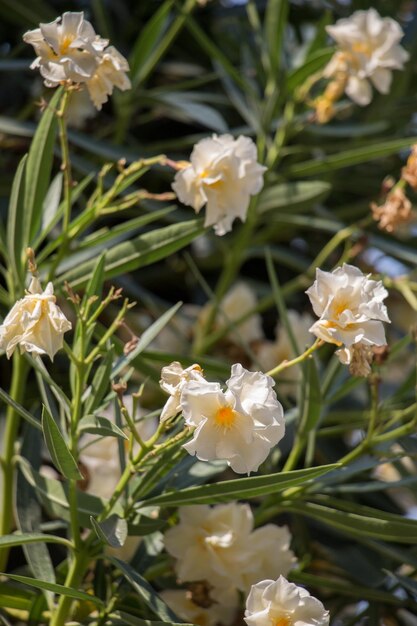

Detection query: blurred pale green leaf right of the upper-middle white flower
(257, 180), (331, 218)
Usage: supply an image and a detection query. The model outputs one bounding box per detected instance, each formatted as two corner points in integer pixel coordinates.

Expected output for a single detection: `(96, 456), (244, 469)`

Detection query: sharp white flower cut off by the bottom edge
(245, 576), (329, 626)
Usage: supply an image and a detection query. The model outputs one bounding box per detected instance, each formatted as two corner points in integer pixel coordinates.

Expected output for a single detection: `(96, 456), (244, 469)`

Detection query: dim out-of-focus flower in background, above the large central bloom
(199, 281), (263, 343)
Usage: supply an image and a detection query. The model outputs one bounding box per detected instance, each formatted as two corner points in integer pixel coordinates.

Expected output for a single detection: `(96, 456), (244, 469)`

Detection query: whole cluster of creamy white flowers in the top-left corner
(23, 12), (130, 110)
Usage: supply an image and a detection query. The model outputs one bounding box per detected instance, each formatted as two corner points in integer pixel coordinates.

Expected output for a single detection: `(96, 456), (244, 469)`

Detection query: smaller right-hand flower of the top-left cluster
(87, 46), (131, 111)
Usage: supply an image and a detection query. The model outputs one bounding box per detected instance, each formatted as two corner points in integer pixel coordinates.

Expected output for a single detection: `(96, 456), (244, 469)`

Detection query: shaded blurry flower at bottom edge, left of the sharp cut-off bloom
(160, 589), (236, 626)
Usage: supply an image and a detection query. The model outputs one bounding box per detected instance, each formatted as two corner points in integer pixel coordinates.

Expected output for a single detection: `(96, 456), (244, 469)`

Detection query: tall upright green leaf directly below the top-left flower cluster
(23, 88), (62, 248)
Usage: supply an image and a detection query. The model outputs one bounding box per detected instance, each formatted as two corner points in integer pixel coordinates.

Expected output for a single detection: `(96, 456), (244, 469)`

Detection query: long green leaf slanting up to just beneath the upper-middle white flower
(60, 219), (205, 289)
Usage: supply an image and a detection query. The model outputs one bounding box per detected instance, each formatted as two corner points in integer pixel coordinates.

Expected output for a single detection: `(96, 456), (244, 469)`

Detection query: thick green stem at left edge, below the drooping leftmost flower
(0, 350), (27, 572)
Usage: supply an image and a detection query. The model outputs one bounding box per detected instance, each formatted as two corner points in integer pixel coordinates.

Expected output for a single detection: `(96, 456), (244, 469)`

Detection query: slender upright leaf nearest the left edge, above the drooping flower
(7, 154), (27, 283)
